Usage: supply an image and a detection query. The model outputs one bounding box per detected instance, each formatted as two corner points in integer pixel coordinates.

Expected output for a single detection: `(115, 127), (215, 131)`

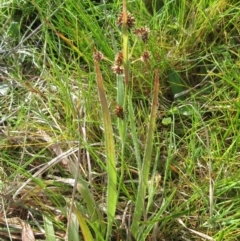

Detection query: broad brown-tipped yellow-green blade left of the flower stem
(95, 56), (117, 240)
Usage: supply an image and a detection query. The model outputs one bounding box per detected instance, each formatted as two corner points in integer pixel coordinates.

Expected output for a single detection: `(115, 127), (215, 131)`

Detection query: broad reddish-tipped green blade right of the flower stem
(131, 71), (159, 237)
